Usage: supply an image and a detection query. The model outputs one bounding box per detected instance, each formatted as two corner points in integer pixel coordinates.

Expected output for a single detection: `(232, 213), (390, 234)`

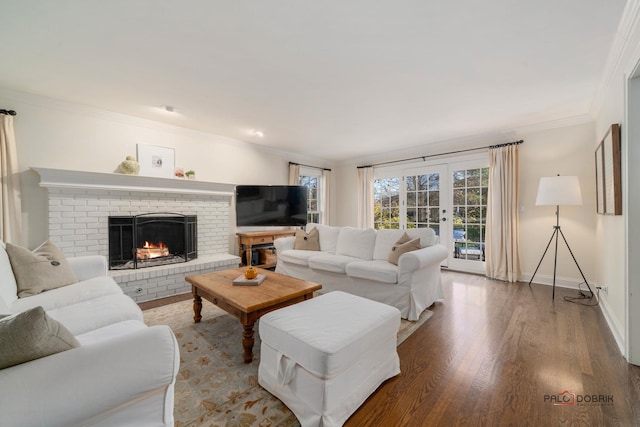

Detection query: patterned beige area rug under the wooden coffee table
(144, 300), (433, 427)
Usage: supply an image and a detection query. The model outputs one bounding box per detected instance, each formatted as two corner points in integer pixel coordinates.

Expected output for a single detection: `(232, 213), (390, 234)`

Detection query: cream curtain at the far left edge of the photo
(0, 114), (22, 245)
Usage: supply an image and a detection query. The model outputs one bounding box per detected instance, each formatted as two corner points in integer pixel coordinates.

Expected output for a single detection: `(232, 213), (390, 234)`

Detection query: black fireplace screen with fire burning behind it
(109, 213), (198, 270)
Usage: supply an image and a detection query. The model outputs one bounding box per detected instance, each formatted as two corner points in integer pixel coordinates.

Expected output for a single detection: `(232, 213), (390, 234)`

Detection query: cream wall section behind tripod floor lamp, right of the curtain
(519, 123), (597, 290)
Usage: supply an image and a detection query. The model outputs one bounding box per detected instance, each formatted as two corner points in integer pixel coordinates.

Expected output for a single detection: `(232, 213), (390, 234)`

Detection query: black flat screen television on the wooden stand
(236, 185), (307, 227)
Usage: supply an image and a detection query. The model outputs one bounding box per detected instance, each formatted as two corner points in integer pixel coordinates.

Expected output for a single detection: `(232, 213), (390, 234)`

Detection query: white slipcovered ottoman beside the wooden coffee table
(258, 291), (400, 427)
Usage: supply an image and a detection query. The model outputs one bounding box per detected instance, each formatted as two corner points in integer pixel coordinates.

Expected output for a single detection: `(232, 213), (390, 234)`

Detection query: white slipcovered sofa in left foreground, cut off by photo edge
(0, 244), (180, 427)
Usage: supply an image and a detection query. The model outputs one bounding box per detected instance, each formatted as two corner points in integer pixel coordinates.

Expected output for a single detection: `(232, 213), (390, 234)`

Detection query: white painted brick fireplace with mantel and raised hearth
(33, 168), (239, 302)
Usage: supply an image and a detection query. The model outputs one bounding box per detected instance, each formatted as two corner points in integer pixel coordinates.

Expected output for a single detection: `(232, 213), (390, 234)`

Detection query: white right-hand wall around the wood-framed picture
(593, 0), (640, 358)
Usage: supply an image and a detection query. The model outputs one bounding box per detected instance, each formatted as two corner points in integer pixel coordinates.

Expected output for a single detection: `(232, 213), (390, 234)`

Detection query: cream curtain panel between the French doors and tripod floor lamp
(485, 144), (521, 282)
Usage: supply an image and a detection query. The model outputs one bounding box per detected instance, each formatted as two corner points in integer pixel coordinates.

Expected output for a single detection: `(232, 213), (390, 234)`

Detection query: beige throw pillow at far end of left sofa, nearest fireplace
(6, 240), (78, 298)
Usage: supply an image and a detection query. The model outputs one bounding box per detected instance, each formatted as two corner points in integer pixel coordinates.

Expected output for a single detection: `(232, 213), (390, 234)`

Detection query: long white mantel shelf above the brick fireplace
(31, 167), (235, 197)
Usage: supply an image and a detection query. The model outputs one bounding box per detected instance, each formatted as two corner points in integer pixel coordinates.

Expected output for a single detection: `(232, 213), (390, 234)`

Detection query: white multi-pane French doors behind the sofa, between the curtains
(374, 156), (489, 273)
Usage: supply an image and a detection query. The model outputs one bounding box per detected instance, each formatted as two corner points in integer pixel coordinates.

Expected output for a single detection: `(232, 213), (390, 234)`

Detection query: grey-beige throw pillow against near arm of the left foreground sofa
(0, 306), (80, 369)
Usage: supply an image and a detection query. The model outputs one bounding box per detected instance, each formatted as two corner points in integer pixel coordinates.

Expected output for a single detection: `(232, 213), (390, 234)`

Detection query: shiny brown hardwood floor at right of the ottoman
(345, 271), (640, 427)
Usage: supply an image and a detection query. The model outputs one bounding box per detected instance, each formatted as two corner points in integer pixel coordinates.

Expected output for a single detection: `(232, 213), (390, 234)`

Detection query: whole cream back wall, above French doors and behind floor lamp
(335, 122), (597, 287)
